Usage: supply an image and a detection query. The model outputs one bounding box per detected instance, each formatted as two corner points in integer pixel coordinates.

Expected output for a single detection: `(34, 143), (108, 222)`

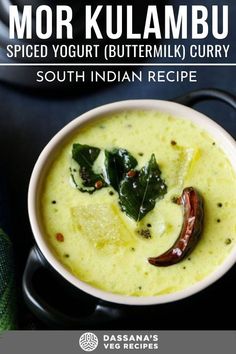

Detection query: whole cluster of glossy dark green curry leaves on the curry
(70, 144), (167, 222)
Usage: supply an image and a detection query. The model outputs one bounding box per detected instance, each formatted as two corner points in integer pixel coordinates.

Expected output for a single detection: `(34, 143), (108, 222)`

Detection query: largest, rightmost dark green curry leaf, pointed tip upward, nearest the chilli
(119, 154), (167, 221)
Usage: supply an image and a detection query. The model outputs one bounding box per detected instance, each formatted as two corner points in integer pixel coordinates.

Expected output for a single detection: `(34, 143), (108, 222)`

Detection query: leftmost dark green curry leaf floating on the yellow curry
(71, 144), (105, 193)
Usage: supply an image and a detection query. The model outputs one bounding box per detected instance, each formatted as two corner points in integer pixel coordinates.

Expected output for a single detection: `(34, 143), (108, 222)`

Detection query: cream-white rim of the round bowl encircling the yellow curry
(28, 99), (236, 305)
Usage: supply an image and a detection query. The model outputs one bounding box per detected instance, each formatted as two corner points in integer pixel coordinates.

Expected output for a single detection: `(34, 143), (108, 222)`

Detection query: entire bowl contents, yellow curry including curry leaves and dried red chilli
(41, 111), (236, 296)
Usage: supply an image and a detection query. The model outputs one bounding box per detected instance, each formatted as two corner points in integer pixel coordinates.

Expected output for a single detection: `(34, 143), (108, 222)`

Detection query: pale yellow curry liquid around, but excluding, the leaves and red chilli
(41, 111), (236, 296)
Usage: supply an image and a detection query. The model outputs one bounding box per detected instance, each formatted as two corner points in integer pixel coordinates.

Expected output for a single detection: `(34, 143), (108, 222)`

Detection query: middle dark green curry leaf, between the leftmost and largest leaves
(105, 149), (138, 192)
